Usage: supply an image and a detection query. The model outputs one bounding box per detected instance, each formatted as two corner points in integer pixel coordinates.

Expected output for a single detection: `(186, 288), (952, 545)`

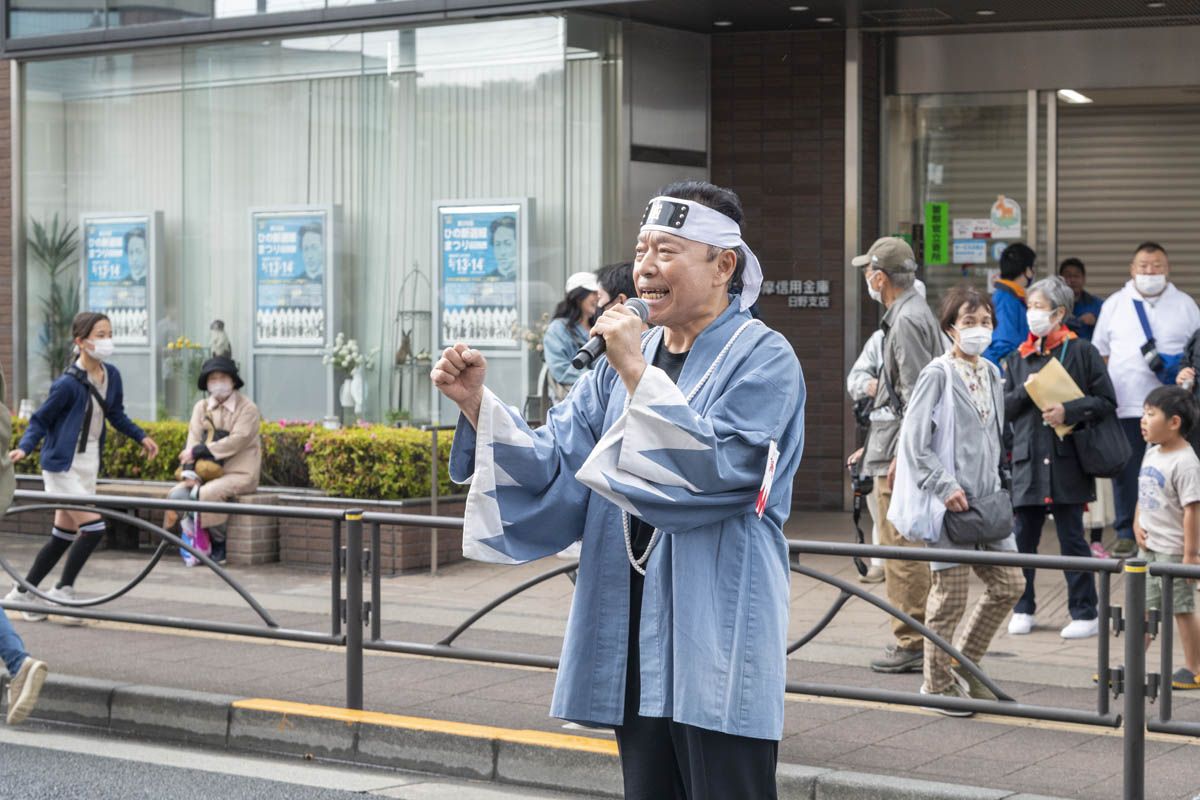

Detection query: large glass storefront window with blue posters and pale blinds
(22, 11), (626, 429)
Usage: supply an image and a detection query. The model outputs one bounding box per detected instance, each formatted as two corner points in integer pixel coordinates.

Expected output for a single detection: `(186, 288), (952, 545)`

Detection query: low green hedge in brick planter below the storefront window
(12, 417), (457, 500)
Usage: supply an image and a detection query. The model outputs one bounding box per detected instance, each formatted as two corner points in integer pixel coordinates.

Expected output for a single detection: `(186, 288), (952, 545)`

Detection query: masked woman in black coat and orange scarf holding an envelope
(1004, 277), (1117, 639)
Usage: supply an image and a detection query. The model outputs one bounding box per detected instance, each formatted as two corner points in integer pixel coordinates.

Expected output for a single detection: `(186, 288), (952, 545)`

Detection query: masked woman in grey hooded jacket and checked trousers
(900, 285), (1021, 716)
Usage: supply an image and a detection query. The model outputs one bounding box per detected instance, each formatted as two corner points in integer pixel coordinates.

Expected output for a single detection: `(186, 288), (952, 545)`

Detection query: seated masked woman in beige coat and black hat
(167, 356), (263, 564)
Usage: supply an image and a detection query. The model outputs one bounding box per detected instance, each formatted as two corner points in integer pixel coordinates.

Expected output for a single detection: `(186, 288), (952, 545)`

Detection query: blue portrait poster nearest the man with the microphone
(437, 203), (524, 349)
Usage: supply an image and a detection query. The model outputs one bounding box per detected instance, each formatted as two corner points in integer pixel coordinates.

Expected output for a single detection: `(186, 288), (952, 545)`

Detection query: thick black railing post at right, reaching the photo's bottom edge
(1122, 559), (1146, 800)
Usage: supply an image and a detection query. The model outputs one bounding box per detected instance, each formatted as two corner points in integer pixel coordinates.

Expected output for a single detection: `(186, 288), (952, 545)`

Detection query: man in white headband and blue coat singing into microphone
(432, 181), (804, 800)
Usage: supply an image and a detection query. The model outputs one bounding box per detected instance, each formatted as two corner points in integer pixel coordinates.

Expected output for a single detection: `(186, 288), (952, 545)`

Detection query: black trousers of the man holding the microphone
(617, 572), (779, 800)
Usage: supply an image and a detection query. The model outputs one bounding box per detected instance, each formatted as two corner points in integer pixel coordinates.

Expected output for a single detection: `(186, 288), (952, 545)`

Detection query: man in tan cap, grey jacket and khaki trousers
(851, 236), (946, 673)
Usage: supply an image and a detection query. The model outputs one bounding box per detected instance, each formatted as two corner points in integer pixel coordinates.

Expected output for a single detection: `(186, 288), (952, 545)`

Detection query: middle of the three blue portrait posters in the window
(251, 209), (332, 347)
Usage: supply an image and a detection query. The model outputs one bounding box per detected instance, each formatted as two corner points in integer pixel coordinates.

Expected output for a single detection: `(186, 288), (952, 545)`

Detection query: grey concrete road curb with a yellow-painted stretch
(0, 674), (1070, 800)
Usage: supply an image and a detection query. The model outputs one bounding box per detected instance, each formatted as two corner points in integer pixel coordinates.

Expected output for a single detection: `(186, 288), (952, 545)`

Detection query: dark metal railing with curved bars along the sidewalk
(0, 491), (1200, 800)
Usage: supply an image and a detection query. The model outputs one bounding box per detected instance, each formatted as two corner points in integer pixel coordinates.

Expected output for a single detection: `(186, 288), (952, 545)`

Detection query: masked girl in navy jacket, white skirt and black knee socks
(6, 311), (158, 624)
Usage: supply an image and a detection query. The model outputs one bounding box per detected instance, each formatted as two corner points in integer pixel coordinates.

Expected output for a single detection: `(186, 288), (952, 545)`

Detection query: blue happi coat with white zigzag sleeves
(450, 303), (804, 739)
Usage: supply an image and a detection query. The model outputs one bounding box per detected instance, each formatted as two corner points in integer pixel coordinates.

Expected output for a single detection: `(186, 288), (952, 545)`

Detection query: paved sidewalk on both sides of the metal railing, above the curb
(0, 515), (1200, 800)
